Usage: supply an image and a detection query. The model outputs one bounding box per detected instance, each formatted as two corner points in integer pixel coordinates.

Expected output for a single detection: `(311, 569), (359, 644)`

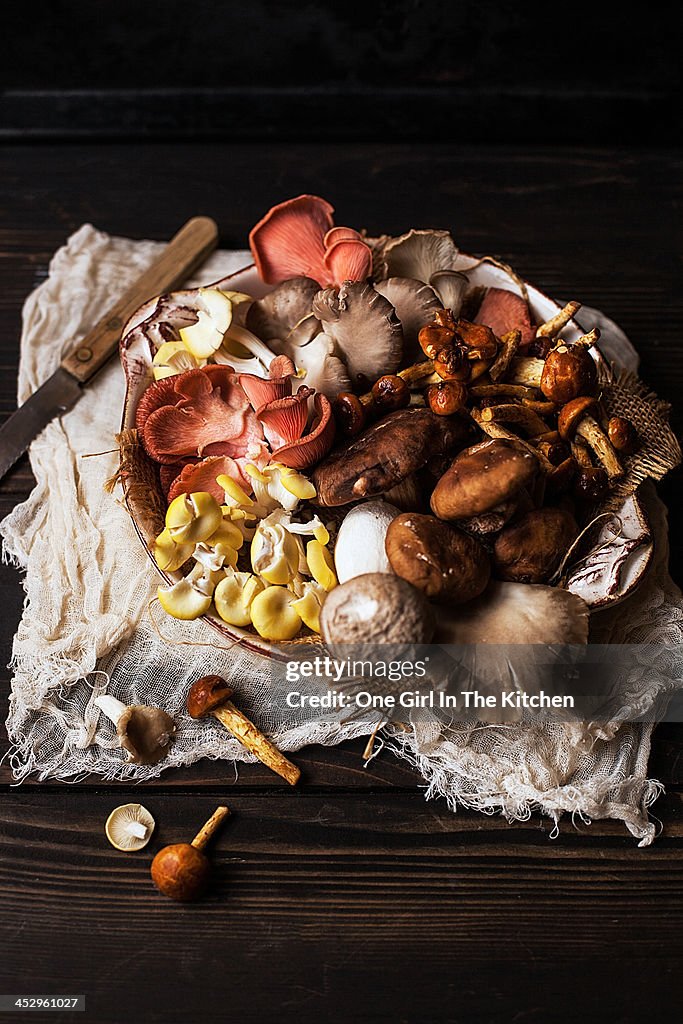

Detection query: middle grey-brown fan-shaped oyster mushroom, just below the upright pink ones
(313, 281), (403, 384)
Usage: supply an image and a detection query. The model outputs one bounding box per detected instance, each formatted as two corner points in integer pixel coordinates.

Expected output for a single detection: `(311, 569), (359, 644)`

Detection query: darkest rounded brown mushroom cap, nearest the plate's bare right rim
(494, 508), (579, 583)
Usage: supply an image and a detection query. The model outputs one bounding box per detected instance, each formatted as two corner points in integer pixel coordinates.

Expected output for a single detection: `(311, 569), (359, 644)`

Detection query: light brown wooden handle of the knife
(61, 217), (218, 384)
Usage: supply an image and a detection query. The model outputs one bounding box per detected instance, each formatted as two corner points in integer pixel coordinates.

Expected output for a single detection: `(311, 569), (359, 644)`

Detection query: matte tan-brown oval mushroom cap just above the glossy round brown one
(431, 438), (538, 519)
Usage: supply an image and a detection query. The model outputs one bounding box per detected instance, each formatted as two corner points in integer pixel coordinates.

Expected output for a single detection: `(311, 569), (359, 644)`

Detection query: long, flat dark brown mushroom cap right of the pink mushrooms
(311, 409), (464, 506)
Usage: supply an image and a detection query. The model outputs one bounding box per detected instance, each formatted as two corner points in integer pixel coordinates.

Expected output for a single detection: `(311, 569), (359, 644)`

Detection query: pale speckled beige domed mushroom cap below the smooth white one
(321, 572), (435, 656)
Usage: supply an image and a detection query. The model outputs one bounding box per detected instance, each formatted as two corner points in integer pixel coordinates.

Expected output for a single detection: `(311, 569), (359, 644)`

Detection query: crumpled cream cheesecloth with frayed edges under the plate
(0, 224), (683, 846)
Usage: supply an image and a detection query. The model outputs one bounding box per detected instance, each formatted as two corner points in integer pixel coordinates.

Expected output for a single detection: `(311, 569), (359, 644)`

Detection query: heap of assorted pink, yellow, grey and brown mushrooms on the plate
(124, 196), (638, 642)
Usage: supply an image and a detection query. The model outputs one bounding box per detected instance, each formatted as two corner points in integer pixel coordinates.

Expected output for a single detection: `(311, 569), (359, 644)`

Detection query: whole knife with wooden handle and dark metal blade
(0, 217), (218, 479)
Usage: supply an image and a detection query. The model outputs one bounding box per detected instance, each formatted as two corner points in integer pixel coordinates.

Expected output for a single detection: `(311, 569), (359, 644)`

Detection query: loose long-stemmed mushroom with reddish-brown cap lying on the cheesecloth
(187, 676), (301, 785)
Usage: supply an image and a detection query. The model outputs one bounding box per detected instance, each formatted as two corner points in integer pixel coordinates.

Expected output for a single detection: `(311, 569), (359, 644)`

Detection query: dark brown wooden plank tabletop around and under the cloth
(0, 144), (683, 1024)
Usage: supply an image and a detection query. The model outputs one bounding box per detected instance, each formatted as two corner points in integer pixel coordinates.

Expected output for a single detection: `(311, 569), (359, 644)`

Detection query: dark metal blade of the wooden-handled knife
(0, 367), (83, 478)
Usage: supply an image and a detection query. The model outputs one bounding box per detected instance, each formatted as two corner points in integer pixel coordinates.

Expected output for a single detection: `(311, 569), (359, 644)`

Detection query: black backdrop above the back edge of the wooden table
(0, 0), (681, 146)
